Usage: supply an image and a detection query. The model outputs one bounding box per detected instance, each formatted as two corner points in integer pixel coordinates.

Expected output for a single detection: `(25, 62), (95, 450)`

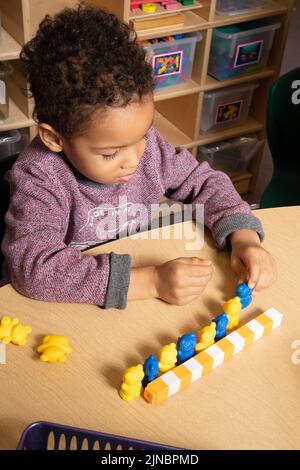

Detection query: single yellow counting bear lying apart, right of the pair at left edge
(37, 335), (72, 362)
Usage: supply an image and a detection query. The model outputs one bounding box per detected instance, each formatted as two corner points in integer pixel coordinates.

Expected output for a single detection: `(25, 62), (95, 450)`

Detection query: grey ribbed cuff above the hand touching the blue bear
(212, 214), (265, 250)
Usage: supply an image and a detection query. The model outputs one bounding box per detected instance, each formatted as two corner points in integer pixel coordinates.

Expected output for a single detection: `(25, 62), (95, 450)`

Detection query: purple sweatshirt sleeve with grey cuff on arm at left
(2, 164), (131, 308)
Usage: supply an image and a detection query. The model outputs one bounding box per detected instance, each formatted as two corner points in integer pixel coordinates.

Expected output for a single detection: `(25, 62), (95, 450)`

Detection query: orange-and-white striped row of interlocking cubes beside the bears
(144, 307), (283, 404)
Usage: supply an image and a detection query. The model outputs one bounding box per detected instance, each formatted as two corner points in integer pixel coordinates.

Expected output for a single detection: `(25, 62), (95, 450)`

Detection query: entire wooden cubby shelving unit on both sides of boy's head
(0, 0), (294, 193)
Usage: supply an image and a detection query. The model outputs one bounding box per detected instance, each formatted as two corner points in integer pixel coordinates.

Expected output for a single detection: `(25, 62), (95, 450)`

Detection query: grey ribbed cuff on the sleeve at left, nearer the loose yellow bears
(104, 252), (131, 308)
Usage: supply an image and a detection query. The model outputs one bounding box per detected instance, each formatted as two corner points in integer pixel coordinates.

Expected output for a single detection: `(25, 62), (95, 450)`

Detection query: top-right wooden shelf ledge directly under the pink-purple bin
(209, 0), (289, 28)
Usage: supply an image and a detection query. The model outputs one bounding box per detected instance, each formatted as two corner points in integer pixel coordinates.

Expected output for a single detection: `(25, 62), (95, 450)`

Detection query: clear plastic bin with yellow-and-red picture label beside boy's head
(144, 33), (202, 88)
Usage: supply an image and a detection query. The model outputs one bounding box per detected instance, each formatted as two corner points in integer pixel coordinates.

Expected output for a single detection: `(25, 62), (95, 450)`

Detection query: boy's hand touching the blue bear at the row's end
(230, 229), (277, 295)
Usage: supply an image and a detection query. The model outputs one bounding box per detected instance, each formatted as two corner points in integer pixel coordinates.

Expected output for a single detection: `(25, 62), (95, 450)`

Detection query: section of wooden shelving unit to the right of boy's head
(91, 0), (294, 193)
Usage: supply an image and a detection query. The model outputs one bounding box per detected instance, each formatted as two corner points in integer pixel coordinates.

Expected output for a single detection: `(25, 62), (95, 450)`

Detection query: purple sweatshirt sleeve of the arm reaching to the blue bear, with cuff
(150, 126), (264, 249)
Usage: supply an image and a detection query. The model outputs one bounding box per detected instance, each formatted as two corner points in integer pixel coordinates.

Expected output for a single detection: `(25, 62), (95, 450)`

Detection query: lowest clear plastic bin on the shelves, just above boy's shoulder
(197, 134), (264, 172)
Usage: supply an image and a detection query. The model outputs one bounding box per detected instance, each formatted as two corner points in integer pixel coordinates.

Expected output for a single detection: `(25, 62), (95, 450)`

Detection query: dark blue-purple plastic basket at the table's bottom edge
(17, 421), (178, 450)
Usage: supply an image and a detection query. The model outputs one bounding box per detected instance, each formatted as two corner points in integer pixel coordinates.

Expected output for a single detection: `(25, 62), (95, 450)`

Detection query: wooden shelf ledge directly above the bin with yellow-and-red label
(137, 11), (208, 40)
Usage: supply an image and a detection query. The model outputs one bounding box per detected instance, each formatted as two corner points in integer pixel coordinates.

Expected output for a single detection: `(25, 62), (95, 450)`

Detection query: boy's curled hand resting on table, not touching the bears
(154, 257), (215, 305)
